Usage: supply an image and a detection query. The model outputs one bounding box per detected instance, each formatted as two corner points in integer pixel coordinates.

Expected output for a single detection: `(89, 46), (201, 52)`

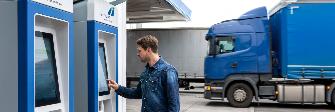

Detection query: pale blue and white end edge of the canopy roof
(166, 0), (192, 20)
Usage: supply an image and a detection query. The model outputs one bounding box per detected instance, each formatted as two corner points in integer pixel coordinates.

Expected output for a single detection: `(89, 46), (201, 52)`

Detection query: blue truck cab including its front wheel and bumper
(204, 7), (272, 107)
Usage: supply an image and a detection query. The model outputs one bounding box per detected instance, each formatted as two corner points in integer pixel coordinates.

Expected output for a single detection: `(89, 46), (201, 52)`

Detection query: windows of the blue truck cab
(208, 36), (234, 55)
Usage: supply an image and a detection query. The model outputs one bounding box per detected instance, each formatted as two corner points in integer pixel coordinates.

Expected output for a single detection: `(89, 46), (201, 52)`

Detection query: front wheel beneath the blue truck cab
(227, 83), (254, 108)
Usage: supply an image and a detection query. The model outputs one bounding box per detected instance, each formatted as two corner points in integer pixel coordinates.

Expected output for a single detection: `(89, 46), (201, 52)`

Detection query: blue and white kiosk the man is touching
(74, 0), (118, 112)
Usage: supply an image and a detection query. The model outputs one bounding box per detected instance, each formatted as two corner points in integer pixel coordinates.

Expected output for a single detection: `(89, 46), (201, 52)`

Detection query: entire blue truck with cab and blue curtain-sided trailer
(204, 0), (335, 107)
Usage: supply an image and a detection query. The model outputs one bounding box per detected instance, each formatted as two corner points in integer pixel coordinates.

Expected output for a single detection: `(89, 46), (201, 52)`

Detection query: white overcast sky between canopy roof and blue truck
(138, 0), (280, 28)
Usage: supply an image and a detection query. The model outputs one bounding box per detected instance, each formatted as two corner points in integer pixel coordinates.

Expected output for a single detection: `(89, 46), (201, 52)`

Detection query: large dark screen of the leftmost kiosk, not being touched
(34, 31), (60, 107)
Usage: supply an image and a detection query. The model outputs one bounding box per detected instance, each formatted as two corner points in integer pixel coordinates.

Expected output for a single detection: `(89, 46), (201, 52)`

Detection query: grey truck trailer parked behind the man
(127, 27), (208, 87)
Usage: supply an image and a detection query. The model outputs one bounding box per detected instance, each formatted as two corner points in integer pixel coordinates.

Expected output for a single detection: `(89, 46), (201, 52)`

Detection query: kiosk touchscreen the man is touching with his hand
(98, 43), (109, 96)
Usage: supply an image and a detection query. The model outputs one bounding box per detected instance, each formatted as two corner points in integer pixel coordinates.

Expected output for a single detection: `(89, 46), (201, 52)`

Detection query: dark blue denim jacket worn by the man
(116, 58), (180, 112)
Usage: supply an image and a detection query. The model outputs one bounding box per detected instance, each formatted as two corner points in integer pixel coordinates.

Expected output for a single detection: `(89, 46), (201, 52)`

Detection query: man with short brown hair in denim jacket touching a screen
(108, 35), (180, 112)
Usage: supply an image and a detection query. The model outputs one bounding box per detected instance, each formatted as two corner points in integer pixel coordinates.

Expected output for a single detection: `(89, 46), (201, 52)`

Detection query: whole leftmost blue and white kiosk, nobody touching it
(0, 0), (74, 112)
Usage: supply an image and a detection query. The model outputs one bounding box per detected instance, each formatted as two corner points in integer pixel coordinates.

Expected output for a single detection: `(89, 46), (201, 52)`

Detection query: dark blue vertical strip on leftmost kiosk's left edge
(18, 0), (29, 112)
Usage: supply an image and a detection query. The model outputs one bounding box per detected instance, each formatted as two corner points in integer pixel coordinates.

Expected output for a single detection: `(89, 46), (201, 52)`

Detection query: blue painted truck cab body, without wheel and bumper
(204, 7), (271, 82)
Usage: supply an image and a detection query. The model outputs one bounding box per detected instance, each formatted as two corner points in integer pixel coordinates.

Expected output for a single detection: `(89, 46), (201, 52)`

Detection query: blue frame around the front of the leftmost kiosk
(18, 0), (74, 112)
